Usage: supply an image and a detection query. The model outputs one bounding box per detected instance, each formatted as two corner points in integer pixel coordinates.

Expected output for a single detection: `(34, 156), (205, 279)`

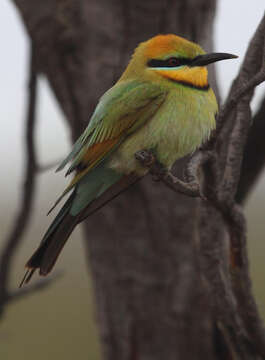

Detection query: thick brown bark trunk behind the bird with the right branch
(0, 0), (265, 360)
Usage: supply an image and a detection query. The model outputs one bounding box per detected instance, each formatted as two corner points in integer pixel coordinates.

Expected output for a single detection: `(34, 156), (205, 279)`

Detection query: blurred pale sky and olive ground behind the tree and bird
(0, 0), (265, 360)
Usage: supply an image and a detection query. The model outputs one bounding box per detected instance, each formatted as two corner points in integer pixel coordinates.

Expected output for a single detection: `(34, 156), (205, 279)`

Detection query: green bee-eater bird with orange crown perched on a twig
(20, 34), (237, 286)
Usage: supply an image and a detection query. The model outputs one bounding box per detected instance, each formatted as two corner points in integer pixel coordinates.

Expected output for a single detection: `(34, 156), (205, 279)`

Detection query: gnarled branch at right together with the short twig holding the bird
(134, 11), (265, 359)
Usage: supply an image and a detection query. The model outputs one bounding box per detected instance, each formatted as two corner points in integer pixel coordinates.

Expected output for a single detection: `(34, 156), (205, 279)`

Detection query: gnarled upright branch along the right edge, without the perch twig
(197, 12), (265, 357)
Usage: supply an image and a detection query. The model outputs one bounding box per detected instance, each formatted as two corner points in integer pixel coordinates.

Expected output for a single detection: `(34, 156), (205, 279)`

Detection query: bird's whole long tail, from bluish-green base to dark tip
(20, 172), (140, 287)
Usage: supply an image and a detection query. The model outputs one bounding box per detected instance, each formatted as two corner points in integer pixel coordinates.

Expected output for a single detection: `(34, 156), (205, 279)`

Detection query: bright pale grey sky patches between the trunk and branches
(0, 0), (265, 202)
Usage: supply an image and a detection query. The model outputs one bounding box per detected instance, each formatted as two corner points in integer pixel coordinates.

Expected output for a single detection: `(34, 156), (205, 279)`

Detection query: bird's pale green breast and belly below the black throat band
(108, 83), (217, 175)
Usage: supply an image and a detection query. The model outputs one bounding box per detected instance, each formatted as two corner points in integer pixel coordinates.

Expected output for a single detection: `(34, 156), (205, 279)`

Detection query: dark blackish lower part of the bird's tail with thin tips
(19, 193), (78, 287)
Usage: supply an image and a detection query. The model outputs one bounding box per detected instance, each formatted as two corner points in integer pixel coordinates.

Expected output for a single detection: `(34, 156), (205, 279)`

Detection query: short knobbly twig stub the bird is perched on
(135, 150), (205, 199)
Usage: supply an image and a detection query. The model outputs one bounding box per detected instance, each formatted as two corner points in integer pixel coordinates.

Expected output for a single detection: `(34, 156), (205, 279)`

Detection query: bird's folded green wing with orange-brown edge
(58, 81), (167, 191)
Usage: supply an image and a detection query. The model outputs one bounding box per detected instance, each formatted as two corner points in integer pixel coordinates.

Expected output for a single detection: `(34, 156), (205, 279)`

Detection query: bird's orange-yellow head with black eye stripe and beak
(121, 34), (237, 88)
